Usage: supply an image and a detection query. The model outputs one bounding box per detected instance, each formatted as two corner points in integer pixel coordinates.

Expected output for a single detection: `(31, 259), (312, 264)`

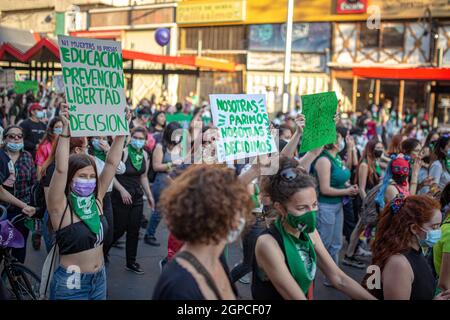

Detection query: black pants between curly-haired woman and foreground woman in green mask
(230, 219), (266, 283)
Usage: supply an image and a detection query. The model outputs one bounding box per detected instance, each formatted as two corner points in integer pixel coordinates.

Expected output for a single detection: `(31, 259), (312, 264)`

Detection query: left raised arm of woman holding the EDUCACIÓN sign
(47, 104), (70, 214)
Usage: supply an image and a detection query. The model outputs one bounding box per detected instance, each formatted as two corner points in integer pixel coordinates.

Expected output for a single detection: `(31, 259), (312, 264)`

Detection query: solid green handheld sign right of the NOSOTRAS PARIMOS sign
(300, 92), (338, 153)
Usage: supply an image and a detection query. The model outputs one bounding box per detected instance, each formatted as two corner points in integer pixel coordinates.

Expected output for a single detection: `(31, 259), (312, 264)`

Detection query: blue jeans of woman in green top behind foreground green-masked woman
(317, 202), (344, 265)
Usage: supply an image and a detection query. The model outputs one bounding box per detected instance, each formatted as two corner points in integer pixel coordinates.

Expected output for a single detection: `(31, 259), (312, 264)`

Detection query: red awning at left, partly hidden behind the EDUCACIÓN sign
(0, 39), (236, 72)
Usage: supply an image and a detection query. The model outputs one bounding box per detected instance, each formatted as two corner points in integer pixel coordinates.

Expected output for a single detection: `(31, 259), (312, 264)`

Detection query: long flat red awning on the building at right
(353, 68), (450, 81)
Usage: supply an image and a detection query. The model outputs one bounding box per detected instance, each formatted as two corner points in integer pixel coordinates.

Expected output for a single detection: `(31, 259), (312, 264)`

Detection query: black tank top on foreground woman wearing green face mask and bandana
(252, 226), (288, 300)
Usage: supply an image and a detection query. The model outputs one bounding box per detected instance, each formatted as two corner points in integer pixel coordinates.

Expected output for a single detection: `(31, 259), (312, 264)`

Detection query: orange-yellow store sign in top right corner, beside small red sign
(370, 0), (450, 19)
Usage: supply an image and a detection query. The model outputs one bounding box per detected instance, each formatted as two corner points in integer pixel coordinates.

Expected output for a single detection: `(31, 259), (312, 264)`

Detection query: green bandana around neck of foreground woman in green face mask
(275, 218), (317, 295)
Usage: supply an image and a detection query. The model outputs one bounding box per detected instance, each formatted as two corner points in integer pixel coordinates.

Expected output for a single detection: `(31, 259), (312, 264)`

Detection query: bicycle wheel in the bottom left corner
(2, 263), (41, 300)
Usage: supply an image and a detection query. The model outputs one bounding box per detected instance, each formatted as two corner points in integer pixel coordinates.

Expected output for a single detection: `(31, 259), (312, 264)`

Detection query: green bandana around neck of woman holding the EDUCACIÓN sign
(70, 192), (101, 235)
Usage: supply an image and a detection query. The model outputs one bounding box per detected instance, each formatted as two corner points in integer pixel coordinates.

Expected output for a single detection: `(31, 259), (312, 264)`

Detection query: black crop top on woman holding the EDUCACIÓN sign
(55, 202), (109, 255)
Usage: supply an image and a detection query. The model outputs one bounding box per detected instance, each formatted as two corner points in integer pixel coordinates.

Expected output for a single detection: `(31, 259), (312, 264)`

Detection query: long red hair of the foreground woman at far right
(372, 195), (441, 270)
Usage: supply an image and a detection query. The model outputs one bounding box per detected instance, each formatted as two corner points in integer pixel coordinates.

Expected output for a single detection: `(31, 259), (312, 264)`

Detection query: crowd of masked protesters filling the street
(0, 86), (450, 300)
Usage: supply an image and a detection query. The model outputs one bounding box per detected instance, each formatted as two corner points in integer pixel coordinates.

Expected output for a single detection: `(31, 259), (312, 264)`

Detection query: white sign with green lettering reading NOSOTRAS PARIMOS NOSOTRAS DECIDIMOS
(209, 94), (278, 162)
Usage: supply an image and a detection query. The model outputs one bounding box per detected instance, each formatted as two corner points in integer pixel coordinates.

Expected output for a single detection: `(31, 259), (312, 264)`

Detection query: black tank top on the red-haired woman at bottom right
(378, 249), (437, 300)
